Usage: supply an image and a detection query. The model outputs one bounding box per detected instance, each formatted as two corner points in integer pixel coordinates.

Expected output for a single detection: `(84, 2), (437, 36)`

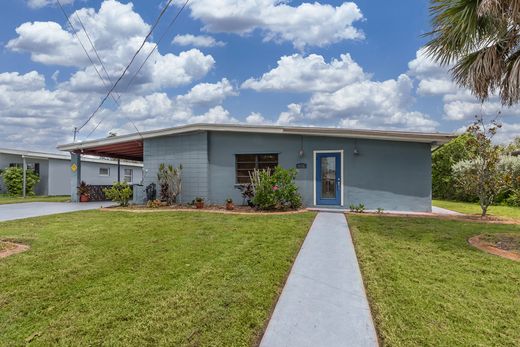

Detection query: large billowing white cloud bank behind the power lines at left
(0, 1), (222, 150)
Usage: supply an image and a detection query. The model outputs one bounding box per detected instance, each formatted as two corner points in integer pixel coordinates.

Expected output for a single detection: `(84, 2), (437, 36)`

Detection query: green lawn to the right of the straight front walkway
(348, 215), (520, 346)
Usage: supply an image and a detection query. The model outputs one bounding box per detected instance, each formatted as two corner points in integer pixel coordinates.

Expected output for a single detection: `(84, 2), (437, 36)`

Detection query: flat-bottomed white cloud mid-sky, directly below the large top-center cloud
(242, 53), (367, 92)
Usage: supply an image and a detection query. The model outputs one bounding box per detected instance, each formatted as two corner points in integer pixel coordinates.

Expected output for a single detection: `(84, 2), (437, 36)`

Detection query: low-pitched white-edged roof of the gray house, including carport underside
(58, 123), (456, 161)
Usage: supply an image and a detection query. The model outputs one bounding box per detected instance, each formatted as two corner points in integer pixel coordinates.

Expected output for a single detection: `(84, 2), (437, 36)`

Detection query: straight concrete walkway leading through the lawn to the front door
(260, 212), (378, 347)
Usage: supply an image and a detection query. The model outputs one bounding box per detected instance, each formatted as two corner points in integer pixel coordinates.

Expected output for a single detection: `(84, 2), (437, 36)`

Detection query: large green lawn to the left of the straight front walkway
(0, 211), (314, 346)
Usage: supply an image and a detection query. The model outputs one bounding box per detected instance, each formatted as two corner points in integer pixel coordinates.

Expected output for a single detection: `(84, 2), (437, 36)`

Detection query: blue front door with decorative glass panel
(315, 152), (343, 206)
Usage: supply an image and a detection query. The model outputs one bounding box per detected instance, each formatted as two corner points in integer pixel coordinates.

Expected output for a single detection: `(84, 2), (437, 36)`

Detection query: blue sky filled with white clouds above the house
(0, 0), (520, 150)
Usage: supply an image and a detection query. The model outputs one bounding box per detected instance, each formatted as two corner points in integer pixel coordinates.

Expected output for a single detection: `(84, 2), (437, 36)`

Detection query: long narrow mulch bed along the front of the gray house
(101, 204), (307, 215)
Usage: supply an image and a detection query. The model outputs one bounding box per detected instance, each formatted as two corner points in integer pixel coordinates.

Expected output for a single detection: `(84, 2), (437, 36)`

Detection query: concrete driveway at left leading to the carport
(0, 202), (109, 222)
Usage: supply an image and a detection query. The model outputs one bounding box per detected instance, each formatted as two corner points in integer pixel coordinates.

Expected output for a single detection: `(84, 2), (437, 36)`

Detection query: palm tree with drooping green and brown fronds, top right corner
(426, 0), (520, 106)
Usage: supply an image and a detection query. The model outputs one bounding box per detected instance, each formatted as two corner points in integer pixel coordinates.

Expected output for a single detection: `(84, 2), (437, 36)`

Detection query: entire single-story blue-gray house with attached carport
(58, 124), (454, 211)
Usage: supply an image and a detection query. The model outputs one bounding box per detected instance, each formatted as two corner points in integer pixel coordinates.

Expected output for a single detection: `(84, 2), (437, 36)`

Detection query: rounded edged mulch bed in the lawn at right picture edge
(468, 234), (520, 261)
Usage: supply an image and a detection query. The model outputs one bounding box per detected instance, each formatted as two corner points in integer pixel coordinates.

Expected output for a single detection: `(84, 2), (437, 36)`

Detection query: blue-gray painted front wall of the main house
(143, 131), (431, 211)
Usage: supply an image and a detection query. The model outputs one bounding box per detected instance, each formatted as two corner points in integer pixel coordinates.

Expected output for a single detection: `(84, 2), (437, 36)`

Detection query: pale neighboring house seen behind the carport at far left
(0, 148), (143, 195)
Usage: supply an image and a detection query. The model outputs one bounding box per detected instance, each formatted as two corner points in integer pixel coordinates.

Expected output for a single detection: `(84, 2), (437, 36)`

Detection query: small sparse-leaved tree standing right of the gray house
(453, 116), (506, 217)
